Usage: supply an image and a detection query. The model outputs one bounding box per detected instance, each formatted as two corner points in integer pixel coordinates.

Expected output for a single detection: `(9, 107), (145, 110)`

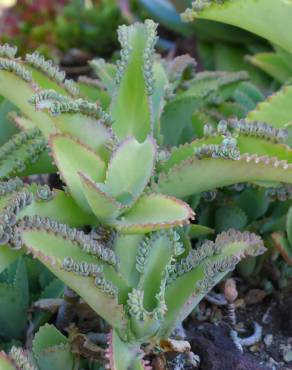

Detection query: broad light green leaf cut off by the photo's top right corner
(185, 0), (292, 52)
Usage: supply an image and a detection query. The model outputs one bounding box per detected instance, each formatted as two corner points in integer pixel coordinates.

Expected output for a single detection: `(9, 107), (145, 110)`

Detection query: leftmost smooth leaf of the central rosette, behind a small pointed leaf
(50, 135), (105, 212)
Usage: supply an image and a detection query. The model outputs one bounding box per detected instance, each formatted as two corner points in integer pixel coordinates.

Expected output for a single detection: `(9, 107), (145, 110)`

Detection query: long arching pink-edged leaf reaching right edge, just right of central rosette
(157, 155), (292, 197)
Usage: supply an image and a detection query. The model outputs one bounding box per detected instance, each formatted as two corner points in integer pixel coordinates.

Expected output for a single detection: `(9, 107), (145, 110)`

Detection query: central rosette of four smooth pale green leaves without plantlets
(50, 135), (193, 233)
